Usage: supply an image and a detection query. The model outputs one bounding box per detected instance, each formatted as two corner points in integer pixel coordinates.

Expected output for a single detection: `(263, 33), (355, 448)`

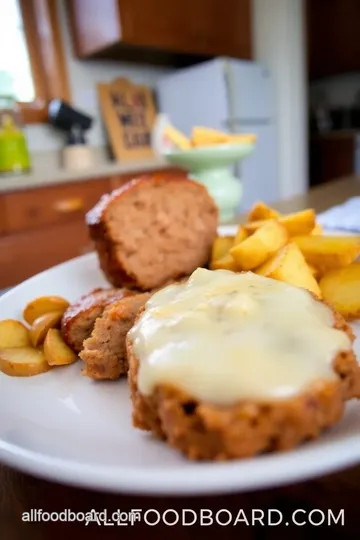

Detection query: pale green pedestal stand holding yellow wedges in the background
(164, 143), (254, 223)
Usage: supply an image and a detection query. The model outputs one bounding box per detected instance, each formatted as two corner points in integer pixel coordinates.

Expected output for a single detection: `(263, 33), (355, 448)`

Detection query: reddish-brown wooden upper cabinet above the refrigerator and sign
(67, 0), (252, 59)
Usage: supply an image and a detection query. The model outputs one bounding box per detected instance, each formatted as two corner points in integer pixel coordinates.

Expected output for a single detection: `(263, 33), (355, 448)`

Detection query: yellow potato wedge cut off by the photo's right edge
(319, 263), (360, 320)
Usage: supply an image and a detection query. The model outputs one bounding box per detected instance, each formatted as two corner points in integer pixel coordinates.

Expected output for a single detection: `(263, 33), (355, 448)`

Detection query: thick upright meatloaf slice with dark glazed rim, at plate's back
(86, 173), (218, 291)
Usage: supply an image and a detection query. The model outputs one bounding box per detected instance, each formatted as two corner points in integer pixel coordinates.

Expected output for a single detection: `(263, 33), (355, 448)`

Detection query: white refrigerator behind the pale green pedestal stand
(156, 58), (279, 210)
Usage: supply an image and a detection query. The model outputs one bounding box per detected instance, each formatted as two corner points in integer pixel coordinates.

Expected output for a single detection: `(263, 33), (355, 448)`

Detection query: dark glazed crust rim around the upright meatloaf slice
(86, 173), (218, 291)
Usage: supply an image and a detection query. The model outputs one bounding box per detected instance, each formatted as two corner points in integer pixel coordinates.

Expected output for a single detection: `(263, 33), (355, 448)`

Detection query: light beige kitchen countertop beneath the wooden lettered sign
(0, 149), (170, 193)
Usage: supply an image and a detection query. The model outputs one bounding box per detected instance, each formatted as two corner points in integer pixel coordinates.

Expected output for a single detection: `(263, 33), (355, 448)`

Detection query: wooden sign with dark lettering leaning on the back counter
(98, 78), (156, 161)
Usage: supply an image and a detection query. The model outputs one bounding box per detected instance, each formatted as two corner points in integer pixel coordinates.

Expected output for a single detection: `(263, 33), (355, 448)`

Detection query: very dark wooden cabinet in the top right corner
(306, 0), (360, 79)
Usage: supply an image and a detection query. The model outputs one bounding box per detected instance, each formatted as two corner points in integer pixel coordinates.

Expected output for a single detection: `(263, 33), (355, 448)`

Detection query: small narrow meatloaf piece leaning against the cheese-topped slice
(79, 293), (151, 379)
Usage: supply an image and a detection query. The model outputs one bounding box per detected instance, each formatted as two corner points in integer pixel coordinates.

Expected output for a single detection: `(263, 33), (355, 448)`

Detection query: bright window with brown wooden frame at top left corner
(0, 0), (69, 123)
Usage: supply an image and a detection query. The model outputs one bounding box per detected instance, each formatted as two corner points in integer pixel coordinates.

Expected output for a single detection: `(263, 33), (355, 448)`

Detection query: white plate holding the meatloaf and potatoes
(0, 228), (360, 495)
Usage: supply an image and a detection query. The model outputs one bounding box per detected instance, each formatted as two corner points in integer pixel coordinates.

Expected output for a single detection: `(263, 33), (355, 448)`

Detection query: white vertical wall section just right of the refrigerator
(253, 0), (309, 198)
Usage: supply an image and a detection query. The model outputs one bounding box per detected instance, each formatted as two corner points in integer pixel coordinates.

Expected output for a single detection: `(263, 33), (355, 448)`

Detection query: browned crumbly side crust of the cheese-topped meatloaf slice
(127, 313), (360, 460)
